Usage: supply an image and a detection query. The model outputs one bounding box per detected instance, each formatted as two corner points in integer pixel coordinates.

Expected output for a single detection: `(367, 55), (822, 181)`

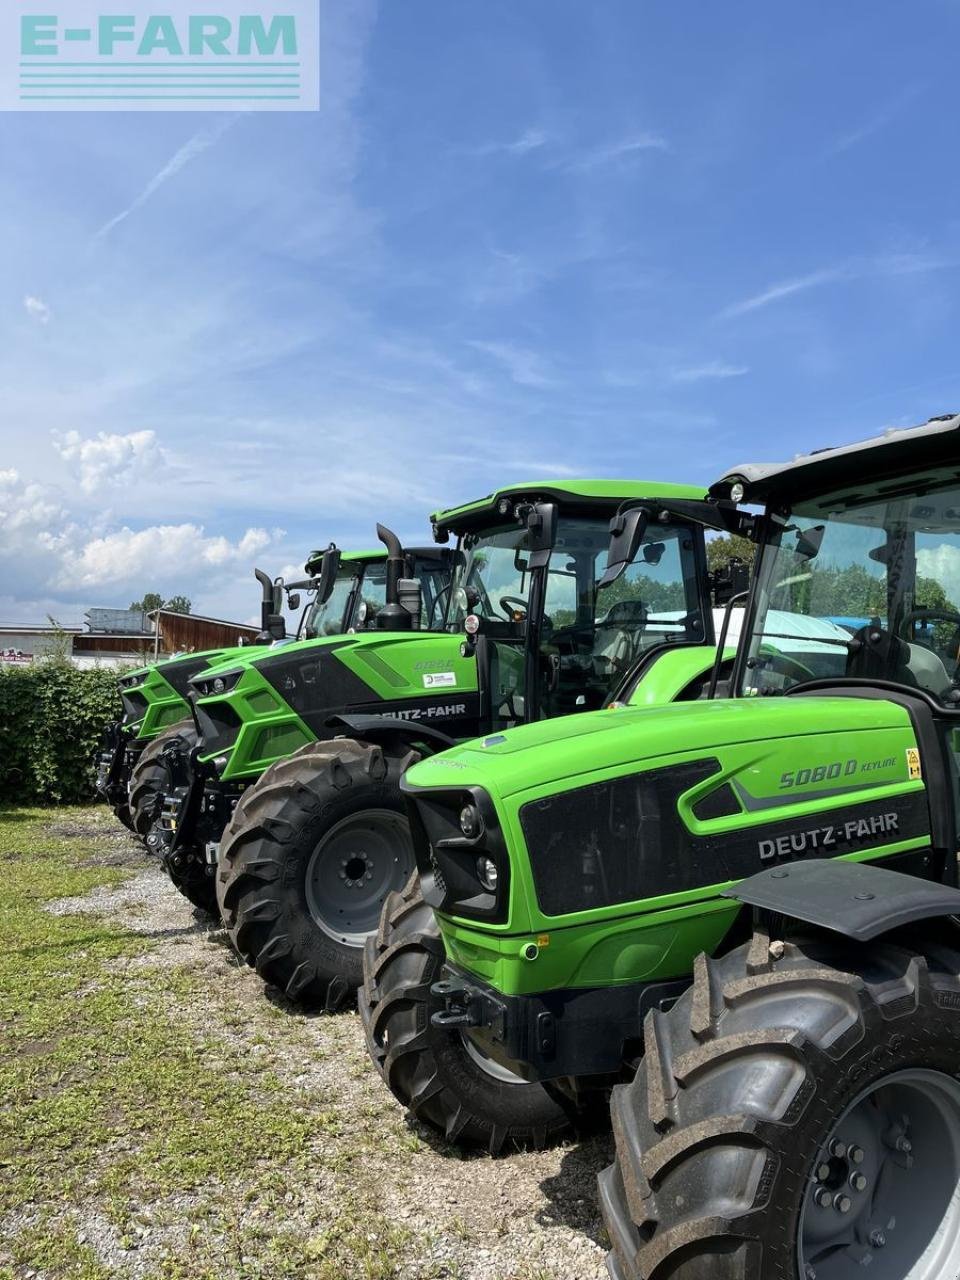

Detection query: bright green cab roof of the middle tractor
(430, 480), (707, 532)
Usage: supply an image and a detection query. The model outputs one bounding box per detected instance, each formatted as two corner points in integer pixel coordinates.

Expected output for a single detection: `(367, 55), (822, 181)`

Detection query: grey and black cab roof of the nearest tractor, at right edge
(710, 413), (960, 507)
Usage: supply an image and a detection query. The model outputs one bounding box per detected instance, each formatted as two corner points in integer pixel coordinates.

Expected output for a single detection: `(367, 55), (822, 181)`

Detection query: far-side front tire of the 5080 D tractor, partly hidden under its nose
(357, 876), (571, 1156)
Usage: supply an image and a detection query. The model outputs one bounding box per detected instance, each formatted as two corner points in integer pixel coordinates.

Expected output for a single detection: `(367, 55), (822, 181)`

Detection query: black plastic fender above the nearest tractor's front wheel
(723, 859), (960, 942)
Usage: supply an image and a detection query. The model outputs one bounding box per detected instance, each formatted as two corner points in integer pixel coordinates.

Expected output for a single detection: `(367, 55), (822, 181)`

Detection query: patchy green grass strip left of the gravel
(0, 810), (403, 1280)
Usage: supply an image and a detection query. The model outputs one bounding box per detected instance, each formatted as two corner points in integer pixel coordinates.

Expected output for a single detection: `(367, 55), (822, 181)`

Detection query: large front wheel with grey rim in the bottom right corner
(600, 928), (960, 1280)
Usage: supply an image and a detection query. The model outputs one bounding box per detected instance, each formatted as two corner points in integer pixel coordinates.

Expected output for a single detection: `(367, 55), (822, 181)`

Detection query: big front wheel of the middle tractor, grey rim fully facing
(216, 739), (419, 1012)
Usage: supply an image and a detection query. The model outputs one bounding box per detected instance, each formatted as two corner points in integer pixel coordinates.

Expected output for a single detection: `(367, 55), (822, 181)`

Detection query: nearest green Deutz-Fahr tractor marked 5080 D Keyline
(391, 416), (960, 1280)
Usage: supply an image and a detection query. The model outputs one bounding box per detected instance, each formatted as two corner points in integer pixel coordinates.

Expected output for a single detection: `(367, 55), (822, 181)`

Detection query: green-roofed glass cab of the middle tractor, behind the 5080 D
(433, 480), (733, 732)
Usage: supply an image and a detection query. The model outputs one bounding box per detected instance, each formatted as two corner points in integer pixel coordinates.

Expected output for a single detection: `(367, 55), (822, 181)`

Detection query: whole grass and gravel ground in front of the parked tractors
(0, 809), (609, 1280)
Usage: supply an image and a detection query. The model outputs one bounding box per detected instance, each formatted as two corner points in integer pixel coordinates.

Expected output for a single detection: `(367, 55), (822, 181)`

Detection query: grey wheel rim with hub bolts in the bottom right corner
(797, 1069), (960, 1280)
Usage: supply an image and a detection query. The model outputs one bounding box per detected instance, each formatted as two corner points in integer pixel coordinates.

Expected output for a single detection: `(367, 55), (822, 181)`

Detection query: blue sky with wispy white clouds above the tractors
(0, 0), (960, 622)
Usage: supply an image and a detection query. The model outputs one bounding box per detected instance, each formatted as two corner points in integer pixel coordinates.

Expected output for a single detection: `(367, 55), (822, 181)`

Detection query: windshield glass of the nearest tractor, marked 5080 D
(740, 486), (960, 699)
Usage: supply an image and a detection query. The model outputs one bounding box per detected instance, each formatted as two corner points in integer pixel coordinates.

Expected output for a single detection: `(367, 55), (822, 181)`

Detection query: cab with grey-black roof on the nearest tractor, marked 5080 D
(712, 417), (960, 710)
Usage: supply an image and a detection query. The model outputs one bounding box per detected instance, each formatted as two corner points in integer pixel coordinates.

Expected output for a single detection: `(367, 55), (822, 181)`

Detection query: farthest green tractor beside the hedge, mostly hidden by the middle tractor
(96, 544), (358, 849)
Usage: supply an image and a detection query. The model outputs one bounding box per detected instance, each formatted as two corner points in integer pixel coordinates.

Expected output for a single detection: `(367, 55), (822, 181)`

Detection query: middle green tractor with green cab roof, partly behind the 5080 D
(181, 480), (742, 1029)
